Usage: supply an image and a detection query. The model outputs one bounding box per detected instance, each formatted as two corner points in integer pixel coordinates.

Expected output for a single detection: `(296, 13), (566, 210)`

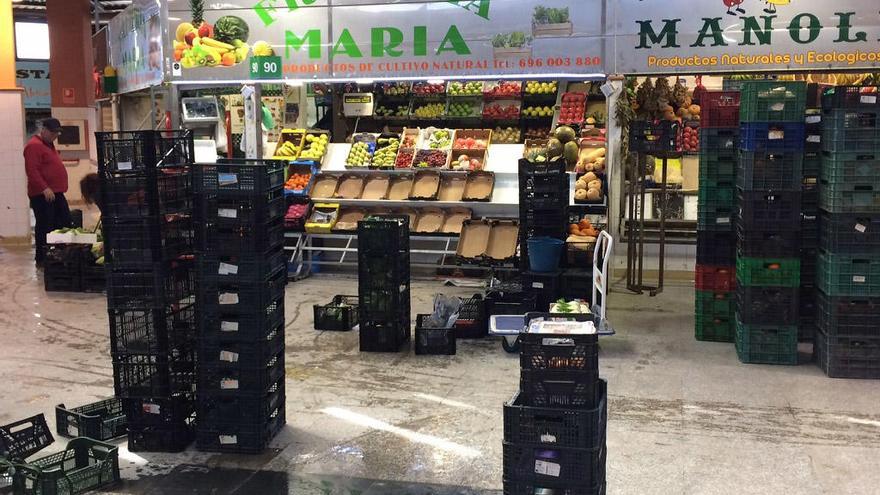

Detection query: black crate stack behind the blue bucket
(519, 159), (569, 311)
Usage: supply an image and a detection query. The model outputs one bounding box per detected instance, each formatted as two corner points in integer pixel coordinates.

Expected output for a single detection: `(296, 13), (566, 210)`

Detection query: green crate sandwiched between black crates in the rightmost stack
(816, 252), (880, 297)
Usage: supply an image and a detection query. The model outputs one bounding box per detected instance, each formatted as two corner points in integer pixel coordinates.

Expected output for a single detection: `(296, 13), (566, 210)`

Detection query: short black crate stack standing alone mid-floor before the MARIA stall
(358, 215), (412, 352)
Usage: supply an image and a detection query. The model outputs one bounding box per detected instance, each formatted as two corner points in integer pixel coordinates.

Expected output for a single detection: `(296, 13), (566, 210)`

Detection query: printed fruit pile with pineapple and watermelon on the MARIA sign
(172, 0), (250, 69)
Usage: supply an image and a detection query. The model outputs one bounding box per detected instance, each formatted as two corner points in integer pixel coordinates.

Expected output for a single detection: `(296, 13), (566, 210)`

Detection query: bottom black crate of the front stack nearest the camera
(503, 442), (606, 493)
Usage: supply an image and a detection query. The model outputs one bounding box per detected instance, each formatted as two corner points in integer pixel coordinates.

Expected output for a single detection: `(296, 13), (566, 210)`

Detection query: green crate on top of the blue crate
(739, 81), (807, 123)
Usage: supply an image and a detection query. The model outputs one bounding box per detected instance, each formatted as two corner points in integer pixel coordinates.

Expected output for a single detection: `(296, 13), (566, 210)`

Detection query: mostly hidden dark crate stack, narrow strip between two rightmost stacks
(798, 106), (822, 342)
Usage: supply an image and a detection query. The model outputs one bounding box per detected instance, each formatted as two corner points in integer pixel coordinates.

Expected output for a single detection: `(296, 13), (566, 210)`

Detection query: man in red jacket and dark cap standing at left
(24, 119), (71, 266)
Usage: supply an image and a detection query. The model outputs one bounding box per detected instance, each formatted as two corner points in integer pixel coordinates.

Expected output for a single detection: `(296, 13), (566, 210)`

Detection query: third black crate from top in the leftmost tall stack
(102, 217), (194, 270)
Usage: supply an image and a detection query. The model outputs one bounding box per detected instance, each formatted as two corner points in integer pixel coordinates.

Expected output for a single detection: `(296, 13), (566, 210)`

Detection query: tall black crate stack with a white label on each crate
(194, 160), (287, 453)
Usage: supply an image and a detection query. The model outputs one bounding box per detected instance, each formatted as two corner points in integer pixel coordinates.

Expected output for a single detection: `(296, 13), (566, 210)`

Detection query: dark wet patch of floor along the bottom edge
(108, 465), (501, 495)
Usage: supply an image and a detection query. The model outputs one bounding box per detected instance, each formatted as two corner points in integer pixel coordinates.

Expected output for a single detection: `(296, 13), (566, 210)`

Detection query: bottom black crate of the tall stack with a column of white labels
(196, 404), (287, 454)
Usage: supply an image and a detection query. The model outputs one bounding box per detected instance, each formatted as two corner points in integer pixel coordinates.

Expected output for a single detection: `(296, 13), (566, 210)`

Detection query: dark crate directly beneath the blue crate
(736, 151), (804, 191)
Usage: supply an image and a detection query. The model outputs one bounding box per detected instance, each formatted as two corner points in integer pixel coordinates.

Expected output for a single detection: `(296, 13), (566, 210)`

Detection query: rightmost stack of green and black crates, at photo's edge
(814, 86), (880, 379)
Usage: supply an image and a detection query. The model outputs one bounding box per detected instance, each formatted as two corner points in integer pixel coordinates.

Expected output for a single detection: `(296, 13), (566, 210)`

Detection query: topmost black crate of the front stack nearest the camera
(519, 333), (599, 375)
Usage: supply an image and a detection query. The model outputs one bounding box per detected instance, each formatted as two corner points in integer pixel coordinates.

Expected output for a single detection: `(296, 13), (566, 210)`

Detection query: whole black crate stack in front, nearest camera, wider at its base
(503, 324), (608, 495)
